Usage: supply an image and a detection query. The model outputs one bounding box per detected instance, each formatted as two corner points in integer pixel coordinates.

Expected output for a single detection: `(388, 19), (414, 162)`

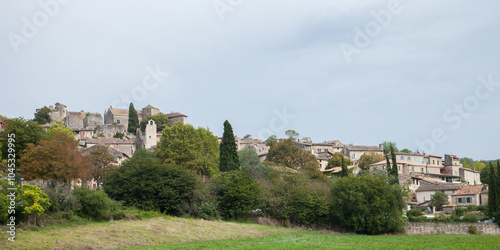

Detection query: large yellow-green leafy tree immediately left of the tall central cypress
(155, 122), (219, 176)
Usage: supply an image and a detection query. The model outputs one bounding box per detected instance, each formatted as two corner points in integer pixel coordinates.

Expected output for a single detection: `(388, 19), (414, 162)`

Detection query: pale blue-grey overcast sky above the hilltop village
(0, 0), (500, 160)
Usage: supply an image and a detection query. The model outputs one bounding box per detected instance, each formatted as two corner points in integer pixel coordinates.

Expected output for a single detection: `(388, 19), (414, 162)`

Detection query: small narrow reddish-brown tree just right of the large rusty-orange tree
(88, 146), (116, 187)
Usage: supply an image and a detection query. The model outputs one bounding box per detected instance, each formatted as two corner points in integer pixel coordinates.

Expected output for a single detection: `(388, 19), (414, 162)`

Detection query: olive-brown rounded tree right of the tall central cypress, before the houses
(266, 139), (319, 169)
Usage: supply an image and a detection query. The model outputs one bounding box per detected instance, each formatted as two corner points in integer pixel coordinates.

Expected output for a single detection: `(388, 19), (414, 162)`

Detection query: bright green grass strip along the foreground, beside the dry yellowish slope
(130, 231), (500, 249)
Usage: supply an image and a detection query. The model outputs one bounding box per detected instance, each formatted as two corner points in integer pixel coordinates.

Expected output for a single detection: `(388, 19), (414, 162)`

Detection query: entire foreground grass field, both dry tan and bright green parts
(0, 216), (500, 249)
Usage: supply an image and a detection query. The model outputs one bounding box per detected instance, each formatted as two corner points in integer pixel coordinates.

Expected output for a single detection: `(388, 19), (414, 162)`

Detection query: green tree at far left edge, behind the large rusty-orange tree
(0, 117), (45, 161)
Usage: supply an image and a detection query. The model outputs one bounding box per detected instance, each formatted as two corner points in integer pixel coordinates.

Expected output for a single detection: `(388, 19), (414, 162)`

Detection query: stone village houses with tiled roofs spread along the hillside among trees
(14, 103), (488, 211)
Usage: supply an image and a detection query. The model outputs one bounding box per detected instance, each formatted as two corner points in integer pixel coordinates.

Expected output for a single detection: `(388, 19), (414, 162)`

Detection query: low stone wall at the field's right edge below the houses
(405, 222), (500, 235)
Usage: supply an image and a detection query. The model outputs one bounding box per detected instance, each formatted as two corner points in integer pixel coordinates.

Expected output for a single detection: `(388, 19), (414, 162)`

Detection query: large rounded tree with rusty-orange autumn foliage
(19, 132), (89, 184)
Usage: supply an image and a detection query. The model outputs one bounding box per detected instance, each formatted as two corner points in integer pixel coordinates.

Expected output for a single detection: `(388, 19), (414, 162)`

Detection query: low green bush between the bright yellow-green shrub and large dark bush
(73, 187), (123, 220)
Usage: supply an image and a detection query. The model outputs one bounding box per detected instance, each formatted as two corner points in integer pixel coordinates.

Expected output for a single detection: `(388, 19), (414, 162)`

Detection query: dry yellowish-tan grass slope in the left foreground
(0, 217), (296, 249)
